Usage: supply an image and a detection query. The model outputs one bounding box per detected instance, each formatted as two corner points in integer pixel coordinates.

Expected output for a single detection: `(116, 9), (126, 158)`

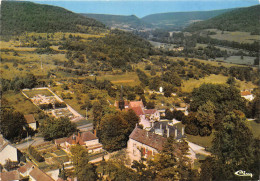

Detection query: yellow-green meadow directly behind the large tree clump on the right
(181, 74), (256, 92)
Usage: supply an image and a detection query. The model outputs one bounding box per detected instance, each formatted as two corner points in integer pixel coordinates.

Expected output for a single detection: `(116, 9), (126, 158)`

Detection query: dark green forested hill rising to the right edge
(186, 5), (260, 34)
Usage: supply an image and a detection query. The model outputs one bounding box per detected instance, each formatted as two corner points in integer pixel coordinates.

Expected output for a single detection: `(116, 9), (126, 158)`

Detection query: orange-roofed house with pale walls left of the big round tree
(55, 131), (103, 153)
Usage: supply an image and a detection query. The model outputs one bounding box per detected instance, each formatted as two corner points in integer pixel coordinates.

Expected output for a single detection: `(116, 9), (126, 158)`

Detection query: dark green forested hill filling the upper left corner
(1, 1), (104, 35)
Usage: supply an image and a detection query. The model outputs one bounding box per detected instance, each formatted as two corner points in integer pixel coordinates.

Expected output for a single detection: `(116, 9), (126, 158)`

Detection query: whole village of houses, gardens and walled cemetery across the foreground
(0, 84), (254, 181)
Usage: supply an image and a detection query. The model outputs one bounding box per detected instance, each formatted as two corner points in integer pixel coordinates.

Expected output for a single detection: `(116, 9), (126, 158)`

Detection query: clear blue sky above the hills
(8, 0), (260, 18)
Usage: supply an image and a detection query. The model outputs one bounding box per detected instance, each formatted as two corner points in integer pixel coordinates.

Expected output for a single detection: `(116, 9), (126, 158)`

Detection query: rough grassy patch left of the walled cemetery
(3, 91), (38, 114)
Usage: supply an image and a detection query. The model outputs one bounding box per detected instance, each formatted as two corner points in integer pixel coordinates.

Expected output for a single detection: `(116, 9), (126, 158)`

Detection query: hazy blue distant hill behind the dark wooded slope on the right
(142, 9), (232, 29)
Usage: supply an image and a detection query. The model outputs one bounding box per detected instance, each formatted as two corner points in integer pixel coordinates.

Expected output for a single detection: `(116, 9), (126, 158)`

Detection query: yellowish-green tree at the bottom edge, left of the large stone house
(70, 145), (98, 181)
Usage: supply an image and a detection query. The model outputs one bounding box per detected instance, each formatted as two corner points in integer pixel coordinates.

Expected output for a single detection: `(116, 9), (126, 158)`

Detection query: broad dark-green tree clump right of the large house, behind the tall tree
(182, 84), (250, 136)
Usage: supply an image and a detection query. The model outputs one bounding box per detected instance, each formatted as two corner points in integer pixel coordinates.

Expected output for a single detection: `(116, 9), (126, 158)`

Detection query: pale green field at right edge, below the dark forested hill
(210, 29), (260, 43)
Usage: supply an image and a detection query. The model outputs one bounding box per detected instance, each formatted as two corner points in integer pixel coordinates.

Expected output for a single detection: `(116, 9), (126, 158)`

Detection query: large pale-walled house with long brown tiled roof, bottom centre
(127, 127), (166, 161)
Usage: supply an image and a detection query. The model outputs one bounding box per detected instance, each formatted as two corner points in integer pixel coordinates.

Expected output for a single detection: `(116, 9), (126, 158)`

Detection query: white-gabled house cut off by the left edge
(0, 134), (23, 165)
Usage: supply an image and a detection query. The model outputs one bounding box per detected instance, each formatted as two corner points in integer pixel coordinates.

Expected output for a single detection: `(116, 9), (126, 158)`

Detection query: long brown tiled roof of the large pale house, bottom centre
(129, 128), (166, 151)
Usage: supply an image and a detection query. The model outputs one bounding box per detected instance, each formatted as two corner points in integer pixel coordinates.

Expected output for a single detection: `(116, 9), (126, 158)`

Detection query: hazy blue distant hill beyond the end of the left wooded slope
(82, 14), (151, 28)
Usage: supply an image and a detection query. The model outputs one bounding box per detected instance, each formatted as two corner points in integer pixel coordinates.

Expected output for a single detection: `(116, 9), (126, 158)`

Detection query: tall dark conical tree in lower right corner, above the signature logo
(199, 112), (259, 180)
